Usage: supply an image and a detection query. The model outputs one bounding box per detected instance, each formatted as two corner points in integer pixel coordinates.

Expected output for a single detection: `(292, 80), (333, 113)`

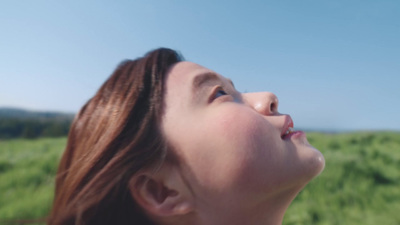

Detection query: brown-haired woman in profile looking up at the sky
(49, 49), (324, 225)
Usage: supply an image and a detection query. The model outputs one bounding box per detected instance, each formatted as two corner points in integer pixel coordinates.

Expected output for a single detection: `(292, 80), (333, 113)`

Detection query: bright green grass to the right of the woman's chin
(283, 132), (400, 225)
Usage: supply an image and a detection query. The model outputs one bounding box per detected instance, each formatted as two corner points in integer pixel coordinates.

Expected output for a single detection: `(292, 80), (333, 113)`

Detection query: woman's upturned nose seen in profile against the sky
(243, 92), (278, 115)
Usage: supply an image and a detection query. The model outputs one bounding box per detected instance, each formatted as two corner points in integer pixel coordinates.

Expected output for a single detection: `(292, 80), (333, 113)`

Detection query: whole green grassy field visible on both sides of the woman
(0, 132), (400, 225)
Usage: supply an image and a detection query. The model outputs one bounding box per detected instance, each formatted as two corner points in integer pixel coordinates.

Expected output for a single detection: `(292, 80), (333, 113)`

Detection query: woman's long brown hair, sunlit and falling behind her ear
(48, 48), (182, 225)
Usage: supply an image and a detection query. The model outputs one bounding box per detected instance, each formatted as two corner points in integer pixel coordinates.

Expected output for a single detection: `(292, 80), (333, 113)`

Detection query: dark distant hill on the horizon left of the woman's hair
(0, 107), (75, 139)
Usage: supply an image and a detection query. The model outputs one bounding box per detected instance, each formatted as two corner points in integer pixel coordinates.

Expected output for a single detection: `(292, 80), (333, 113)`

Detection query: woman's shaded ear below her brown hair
(129, 165), (194, 217)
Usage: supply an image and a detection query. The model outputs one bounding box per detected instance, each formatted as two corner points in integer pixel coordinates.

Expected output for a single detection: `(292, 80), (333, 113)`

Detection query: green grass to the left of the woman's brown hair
(0, 138), (66, 223)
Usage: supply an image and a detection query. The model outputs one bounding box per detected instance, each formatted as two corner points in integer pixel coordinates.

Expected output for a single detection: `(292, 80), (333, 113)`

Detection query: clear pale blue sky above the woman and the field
(0, 0), (400, 130)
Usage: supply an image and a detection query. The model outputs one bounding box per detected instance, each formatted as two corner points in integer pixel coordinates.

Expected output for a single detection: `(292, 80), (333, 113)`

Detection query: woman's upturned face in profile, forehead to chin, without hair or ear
(162, 62), (324, 212)
